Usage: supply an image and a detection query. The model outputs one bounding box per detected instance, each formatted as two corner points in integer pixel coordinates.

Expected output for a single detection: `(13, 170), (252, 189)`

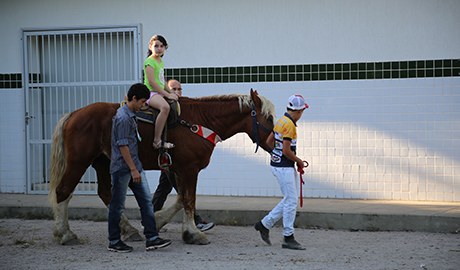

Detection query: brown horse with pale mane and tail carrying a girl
(49, 90), (274, 244)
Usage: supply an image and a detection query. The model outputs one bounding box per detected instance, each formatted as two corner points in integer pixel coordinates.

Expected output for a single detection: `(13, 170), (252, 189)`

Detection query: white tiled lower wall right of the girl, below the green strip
(181, 78), (460, 201)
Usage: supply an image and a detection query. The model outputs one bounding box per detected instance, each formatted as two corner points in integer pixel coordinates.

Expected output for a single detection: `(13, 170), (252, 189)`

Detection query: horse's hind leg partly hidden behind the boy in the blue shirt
(92, 155), (143, 241)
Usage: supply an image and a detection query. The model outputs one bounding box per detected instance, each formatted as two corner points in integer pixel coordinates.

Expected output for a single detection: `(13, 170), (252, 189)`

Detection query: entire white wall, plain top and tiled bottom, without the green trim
(0, 0), (460, 201)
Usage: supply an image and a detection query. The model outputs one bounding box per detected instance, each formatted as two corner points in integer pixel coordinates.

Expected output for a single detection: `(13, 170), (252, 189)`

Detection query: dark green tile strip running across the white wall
(0, 59), (460, 88)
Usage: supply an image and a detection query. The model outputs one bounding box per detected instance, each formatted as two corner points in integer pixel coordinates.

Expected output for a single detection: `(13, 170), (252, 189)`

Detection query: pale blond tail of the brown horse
(48, 113), (71, 209)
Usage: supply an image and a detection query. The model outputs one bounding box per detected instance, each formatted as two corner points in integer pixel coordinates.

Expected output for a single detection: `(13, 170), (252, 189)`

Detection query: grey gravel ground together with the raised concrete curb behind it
(0, 194), (460, 270)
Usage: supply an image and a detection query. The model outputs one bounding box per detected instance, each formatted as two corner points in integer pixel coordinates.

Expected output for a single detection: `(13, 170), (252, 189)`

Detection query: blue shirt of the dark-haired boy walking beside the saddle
(110, 105), (142, 173)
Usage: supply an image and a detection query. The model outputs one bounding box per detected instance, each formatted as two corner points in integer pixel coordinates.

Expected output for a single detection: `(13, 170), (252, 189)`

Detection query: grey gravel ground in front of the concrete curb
(0, 218), (460, 270)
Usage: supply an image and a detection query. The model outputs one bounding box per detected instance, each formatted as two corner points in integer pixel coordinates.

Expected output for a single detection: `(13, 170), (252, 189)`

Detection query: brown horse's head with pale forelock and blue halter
(240, 89), (275, 153)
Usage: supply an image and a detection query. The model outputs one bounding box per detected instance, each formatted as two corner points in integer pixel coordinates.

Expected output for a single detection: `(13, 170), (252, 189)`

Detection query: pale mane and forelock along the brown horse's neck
(180, 94), (275, 119)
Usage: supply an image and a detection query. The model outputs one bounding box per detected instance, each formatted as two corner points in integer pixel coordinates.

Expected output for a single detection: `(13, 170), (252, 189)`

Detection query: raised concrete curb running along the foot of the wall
(0, 194), (460, 233)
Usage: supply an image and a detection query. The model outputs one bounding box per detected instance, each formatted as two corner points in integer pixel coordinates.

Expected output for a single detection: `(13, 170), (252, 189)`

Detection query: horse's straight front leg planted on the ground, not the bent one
(178, 173), (209, 245)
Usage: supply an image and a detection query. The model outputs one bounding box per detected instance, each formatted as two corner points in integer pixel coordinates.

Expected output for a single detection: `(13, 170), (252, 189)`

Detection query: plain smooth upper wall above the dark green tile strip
(0, 0), (460, 73)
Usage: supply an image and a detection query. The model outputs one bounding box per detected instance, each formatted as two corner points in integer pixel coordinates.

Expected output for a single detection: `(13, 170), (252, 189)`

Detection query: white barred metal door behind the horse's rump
(23, 26), (141, 194)
